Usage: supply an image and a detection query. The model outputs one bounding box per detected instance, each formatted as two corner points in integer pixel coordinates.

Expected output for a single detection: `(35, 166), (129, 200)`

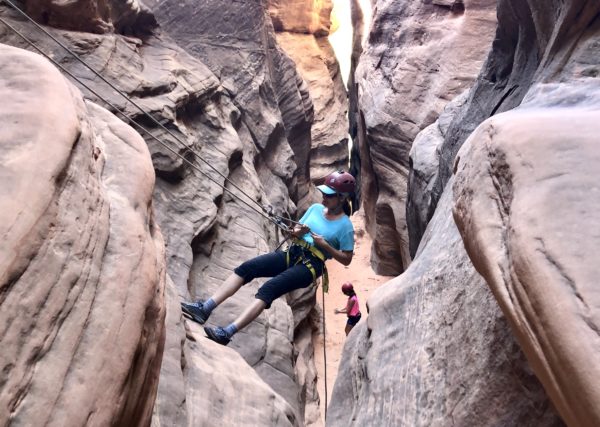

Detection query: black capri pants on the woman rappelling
(233, 245), (323, 308)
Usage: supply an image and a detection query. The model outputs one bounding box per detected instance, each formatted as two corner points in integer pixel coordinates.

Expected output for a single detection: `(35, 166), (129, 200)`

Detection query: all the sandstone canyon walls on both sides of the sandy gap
(0, 0), (600, 426)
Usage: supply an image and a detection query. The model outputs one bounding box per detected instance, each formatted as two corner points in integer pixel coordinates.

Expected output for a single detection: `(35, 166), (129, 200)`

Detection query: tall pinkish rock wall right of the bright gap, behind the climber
(355, 0), (496, 275)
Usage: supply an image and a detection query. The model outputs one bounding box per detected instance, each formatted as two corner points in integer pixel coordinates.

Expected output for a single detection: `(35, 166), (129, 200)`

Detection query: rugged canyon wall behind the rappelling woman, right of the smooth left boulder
(0, 1), (338, 425)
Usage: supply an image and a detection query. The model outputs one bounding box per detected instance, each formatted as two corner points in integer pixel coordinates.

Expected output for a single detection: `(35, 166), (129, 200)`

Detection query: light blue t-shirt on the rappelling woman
(300, 203), (354, 258)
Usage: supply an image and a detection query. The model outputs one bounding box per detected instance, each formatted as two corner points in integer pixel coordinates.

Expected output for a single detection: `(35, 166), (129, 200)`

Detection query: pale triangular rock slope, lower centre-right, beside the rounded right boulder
(327, 178), (562, 427)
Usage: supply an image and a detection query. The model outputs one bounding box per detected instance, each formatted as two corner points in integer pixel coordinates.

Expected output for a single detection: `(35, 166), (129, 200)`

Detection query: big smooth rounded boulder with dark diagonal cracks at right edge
(454, 106), (600, 426)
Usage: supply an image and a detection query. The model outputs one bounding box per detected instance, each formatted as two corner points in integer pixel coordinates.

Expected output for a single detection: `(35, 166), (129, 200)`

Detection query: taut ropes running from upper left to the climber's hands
(0, 0), (298, 232)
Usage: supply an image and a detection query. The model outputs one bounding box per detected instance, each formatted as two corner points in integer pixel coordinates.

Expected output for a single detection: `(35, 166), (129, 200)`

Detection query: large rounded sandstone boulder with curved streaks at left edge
(0, 45), (165, 425)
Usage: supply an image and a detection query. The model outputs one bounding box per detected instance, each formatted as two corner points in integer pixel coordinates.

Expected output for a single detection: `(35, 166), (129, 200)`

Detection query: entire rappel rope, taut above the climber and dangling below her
(0, 5), (327, 414)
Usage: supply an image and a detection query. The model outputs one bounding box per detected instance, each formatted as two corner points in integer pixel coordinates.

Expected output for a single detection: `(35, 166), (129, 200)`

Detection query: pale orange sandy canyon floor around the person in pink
(313, 211), (391, 419)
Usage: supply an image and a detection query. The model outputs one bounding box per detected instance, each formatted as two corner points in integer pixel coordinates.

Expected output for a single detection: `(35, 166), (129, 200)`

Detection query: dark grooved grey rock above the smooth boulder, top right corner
(434, 0), (600, 221)
